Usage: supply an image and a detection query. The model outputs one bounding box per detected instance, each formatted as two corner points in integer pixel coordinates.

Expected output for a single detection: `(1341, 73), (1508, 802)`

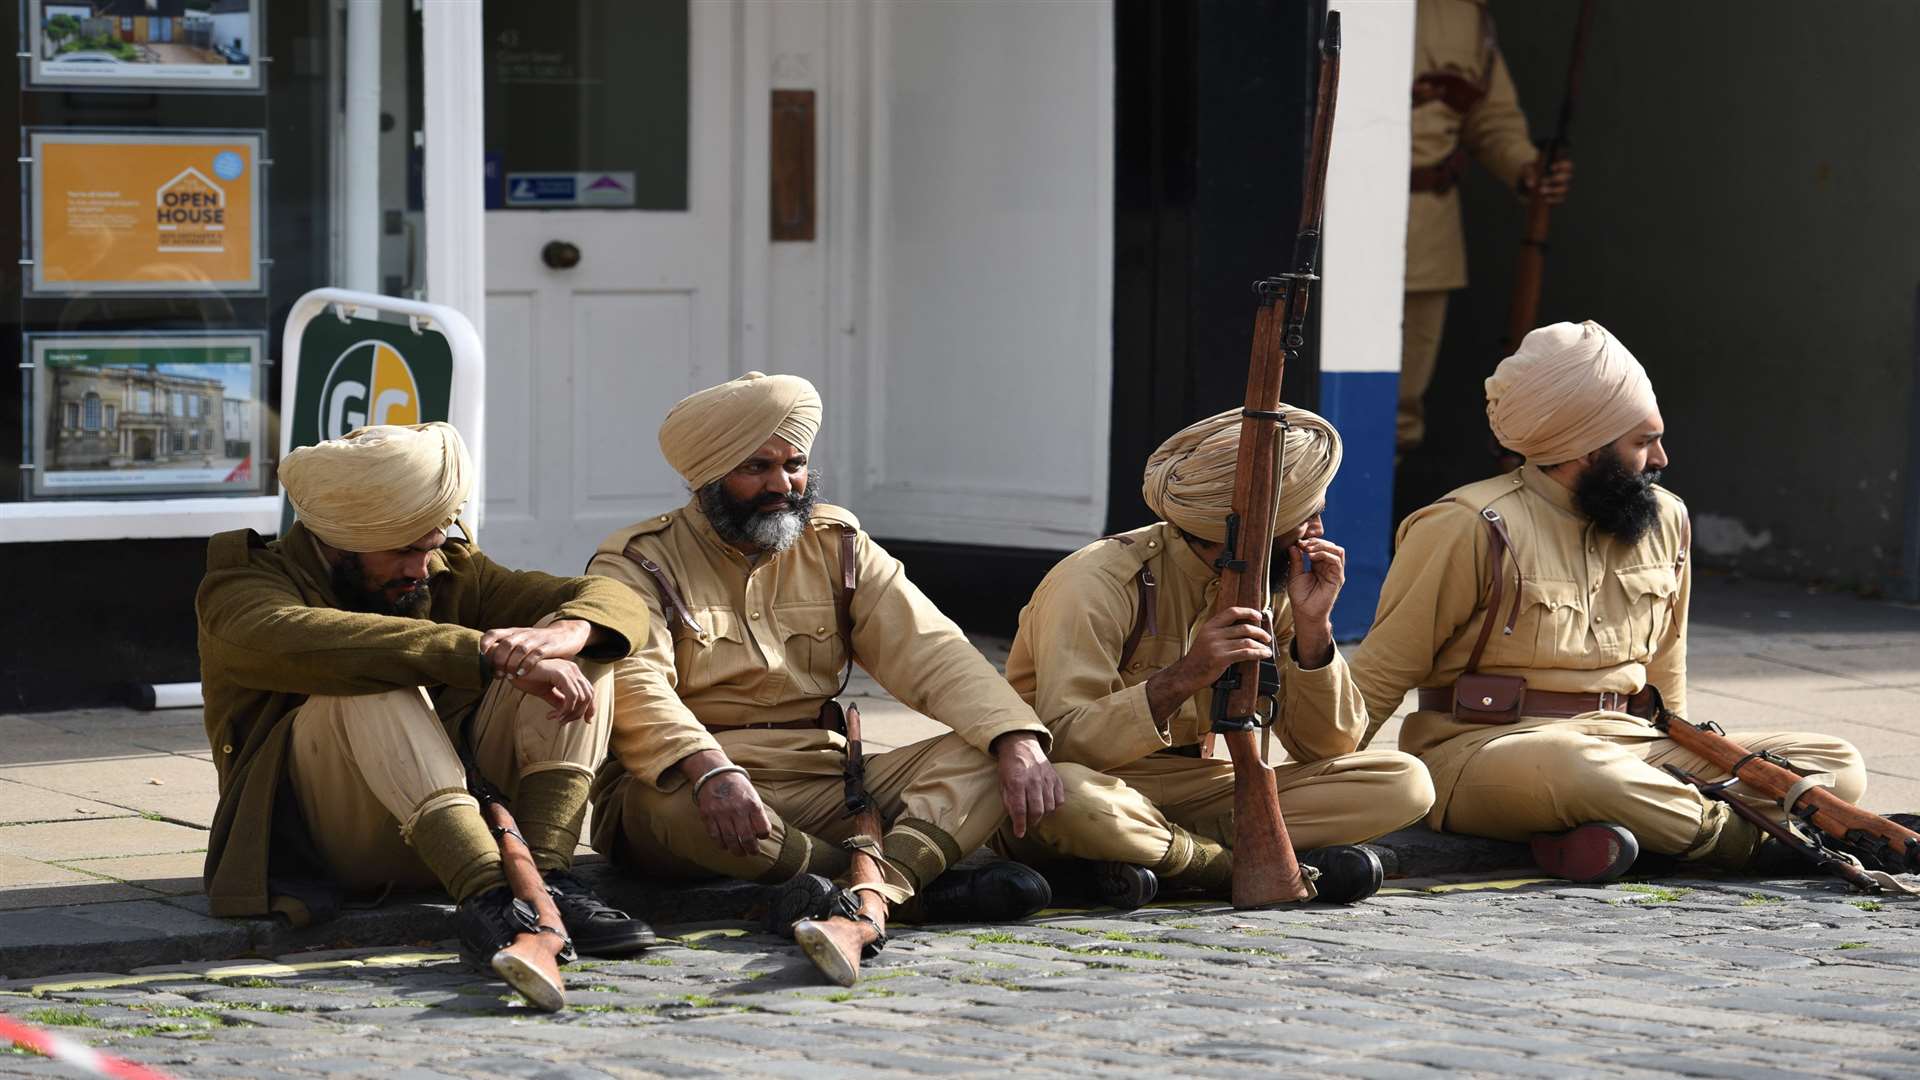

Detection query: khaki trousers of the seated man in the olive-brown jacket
(288, 663), (612, 890)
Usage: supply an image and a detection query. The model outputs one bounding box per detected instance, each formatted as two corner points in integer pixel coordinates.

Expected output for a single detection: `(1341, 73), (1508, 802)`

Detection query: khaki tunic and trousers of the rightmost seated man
(1354, 465), (1864, 853)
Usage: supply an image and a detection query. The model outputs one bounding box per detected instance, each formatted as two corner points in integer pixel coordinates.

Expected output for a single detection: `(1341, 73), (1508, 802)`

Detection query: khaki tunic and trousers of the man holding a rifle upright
(1000, 523), (1432, 872)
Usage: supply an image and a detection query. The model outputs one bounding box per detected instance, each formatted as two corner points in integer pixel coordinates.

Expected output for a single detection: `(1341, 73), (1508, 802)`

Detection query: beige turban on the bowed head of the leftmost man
(280, 423), (474, 552)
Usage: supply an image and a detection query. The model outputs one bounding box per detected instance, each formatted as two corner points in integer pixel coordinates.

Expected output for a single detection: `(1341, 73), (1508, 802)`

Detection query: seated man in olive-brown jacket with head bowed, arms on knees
(196, 423), (653, 991)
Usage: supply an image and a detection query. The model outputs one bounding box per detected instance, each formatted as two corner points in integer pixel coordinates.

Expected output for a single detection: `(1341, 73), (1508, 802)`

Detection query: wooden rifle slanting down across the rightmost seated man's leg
(1653, 707), (1920, 874)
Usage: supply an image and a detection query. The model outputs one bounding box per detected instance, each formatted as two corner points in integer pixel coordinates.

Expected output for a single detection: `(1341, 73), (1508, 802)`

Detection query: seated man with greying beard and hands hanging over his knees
(588, 371), (1060, 932)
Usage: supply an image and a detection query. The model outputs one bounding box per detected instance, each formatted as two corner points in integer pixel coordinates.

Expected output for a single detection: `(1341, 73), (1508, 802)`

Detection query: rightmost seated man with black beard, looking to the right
(1354, 323), (1866, 882)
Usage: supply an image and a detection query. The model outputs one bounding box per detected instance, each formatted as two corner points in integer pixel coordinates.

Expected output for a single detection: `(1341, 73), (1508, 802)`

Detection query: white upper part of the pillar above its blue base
(1321, 0), (1413, 371)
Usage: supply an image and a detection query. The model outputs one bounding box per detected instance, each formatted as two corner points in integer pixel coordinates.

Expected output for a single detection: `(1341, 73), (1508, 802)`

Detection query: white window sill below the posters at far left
(0, 496), (280, 544)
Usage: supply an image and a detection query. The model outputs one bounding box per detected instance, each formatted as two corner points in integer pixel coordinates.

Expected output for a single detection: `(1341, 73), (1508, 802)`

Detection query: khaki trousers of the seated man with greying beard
(593, 728), (1006, 884)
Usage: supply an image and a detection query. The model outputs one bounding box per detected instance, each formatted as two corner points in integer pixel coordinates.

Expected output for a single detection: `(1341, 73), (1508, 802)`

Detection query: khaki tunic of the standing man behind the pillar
(1405, 0), (1540, 292)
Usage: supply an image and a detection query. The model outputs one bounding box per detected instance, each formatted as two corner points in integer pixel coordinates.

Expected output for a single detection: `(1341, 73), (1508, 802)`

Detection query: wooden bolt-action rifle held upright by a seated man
(1213, 12), (1340, 907)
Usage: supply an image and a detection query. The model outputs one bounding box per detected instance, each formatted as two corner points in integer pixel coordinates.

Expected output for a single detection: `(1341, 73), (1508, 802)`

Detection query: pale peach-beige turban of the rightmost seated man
(1486, 321), (1659, 465)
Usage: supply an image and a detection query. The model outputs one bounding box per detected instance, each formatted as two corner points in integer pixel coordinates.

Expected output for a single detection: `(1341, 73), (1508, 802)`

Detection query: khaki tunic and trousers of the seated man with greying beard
(588, 503), (1050, 876)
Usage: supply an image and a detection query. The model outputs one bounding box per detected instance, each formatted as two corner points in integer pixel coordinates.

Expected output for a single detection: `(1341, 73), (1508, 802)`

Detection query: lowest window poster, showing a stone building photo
(27, 334), (265, 496)
